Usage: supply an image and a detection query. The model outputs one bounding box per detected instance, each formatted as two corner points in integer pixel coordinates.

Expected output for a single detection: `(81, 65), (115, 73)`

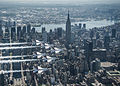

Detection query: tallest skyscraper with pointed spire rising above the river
(66, 11), (71, 45)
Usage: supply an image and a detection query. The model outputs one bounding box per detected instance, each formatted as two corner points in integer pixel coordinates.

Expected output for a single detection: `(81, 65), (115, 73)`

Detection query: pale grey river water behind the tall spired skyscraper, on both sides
(35, 20), (114, 32)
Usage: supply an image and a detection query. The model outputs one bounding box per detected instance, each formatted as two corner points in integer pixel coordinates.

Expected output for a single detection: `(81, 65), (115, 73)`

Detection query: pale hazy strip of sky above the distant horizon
(0, 0), (120, 4)
